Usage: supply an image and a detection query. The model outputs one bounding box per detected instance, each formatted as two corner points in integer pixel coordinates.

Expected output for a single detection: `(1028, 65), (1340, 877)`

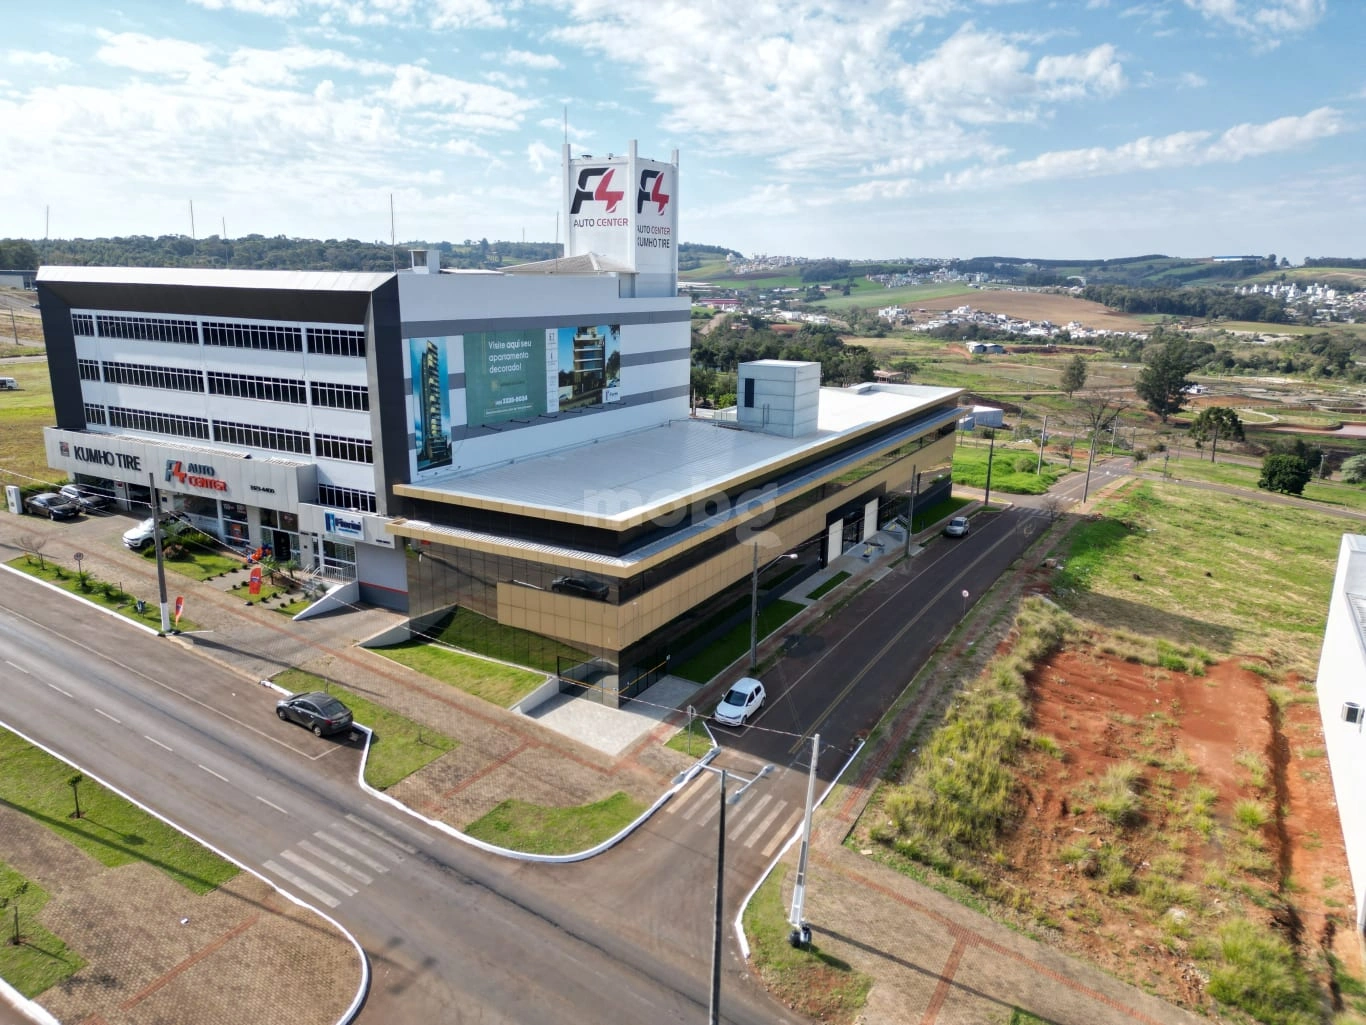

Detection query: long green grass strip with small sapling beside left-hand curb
(0, 730), (238, 894)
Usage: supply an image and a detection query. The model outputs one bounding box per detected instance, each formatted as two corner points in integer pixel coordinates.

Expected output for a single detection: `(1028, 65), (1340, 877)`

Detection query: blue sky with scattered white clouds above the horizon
(0, 0), (1366, 262)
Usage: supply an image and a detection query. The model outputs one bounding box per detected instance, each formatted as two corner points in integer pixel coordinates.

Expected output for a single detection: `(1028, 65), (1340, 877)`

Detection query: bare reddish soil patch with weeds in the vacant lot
(994, 648), (1362, 1007)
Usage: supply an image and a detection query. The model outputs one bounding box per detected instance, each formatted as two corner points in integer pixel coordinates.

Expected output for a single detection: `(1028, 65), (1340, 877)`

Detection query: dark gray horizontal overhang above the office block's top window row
(42, 280), (377, 324)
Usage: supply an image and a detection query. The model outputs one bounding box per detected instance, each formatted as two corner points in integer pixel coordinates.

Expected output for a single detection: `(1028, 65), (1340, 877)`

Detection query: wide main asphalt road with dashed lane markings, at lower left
(0, 575), (803, 1025)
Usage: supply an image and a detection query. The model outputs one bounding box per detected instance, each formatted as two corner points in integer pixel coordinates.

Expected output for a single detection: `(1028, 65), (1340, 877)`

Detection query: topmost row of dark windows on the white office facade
(71, 313), (365, 357)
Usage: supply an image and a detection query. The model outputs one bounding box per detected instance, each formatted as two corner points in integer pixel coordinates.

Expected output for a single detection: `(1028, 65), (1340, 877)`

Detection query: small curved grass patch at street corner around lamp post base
(744, 868), (873, 1025)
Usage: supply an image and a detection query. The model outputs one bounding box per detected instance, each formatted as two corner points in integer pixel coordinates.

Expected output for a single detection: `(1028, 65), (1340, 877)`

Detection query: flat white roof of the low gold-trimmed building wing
(421, 384), (959, 522)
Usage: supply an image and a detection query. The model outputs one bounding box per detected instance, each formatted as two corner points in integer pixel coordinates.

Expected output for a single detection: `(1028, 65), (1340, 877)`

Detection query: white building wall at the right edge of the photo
(1317, 534), (1366, 933)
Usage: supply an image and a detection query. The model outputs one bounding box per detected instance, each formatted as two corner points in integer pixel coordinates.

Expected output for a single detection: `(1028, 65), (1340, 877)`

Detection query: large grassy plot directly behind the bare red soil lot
(1055, 480), (1333, 679)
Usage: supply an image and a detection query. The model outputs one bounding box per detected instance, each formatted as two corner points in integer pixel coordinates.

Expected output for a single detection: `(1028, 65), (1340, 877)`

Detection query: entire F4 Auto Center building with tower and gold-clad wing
(38, 145), (959, 701)
